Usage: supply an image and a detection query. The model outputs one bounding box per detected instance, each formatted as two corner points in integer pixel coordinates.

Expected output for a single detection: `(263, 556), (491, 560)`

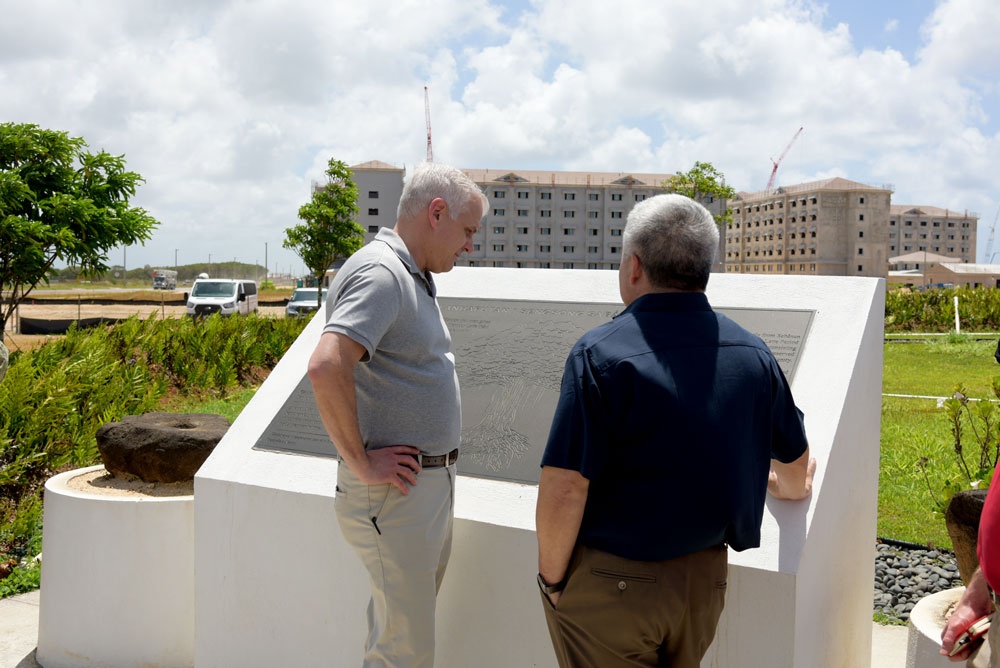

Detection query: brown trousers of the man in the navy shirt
(542, 546), (728, 668)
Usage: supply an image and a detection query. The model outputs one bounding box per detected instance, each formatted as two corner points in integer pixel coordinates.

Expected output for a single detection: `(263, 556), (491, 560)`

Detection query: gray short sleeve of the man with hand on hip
(323, 264), (402, 362)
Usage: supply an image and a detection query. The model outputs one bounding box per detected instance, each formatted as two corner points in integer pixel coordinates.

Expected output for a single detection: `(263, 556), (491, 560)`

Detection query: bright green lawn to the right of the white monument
(878, 340), (1000, 548)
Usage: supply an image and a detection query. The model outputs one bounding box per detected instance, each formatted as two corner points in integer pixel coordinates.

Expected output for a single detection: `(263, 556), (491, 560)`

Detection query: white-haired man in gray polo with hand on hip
(309, 163), (489, 668)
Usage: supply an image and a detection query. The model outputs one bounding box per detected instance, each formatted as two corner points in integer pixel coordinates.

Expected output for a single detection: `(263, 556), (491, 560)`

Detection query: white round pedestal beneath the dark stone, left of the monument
(37, 466), (194, 668)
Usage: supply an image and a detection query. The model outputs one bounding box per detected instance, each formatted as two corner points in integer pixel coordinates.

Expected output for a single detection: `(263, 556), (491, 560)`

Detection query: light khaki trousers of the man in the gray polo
(334, 463), (455, 668)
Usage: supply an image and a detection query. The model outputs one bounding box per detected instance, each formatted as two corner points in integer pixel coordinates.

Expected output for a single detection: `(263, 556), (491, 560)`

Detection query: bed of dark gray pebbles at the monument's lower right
(872, 540), (963, 622)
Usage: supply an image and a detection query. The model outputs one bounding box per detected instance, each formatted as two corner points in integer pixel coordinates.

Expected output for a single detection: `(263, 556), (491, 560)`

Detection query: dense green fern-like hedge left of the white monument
(0, 315), (307, 596)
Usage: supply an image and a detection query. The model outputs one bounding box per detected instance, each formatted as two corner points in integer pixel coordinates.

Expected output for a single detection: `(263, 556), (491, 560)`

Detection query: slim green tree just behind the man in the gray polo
(282, 158), (365, 306)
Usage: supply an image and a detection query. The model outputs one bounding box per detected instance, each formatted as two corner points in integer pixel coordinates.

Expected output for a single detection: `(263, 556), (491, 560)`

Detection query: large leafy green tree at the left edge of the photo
(0, 123), (158, 336)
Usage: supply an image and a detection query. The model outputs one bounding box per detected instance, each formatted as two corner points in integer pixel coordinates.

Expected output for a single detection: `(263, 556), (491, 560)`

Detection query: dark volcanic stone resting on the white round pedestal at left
(97, 413), (229, 482)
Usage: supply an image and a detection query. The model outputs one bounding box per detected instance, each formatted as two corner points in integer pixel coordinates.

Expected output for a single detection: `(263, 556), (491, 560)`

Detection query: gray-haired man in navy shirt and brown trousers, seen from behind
(536, 195), (816, 668)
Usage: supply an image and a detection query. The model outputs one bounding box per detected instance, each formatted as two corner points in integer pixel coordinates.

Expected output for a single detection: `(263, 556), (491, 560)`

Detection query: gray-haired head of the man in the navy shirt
(622, 194), (719, 290)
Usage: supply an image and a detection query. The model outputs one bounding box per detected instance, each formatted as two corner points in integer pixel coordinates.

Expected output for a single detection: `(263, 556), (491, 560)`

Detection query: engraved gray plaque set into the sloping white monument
(254, 298), (814, 484)
